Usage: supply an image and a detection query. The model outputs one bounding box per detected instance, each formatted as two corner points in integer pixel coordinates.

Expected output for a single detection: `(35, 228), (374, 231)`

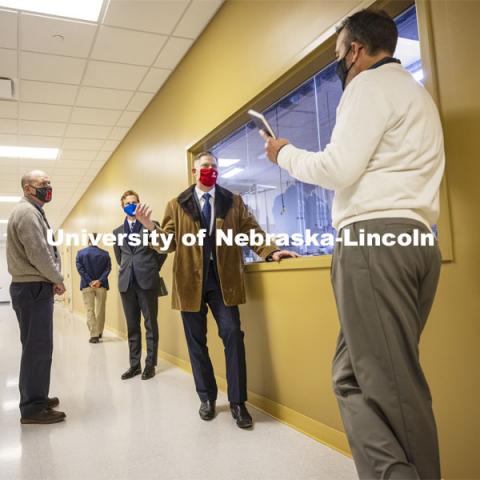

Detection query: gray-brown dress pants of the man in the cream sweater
(331, 218), (441, 479)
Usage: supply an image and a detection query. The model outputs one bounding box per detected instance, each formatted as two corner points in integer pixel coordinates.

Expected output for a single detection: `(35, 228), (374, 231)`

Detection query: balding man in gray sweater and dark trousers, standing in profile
(7, 170), (65, 424)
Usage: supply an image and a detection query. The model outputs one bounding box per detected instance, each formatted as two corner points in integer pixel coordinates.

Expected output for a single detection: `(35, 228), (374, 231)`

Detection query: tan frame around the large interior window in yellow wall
(186, 0), (454, 273)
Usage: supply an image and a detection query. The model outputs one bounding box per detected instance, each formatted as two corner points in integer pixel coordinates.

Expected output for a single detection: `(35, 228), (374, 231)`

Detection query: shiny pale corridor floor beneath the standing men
(0, 304), (356, 480)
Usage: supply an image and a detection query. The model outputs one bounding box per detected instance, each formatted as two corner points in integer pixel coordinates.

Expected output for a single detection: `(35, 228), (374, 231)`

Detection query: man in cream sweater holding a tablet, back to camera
(263, 10), (444, 479)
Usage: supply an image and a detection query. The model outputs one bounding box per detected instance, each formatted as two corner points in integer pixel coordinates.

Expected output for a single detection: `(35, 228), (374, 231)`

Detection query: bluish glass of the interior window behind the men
(212, 6), (423, 262)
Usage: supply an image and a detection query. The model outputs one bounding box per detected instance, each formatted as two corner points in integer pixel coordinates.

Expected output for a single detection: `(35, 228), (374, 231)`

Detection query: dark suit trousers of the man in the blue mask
(120, 282), (158, 367)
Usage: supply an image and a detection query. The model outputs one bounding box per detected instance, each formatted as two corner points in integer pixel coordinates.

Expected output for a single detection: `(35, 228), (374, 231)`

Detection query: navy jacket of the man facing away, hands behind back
(76, 246), (112, 290)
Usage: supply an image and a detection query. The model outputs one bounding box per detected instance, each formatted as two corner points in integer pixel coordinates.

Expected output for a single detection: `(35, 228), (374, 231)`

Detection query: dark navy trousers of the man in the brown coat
(181, 264), (247, 403)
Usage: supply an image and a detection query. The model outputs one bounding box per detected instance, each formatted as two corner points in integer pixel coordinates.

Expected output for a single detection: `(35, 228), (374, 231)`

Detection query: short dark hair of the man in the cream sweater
(337, 8), (398, 55)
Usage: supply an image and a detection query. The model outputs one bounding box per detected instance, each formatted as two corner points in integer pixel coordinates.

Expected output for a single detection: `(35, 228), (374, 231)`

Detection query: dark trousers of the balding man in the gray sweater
(10, 282), (53, 417)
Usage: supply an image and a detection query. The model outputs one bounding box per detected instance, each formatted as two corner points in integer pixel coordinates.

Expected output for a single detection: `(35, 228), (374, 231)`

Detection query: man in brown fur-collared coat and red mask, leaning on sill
(136, 152), (297, 428)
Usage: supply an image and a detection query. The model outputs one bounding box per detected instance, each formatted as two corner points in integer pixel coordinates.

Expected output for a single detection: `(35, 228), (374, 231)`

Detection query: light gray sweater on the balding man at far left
(7, 197), (63, 283)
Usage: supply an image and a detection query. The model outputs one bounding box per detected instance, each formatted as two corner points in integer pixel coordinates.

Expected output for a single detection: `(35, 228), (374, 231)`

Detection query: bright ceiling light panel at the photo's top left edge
(0, 0), (103, 22)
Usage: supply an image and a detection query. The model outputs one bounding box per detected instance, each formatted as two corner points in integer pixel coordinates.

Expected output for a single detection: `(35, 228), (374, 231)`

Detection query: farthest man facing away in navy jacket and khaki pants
(76, 238), (112, 343)
